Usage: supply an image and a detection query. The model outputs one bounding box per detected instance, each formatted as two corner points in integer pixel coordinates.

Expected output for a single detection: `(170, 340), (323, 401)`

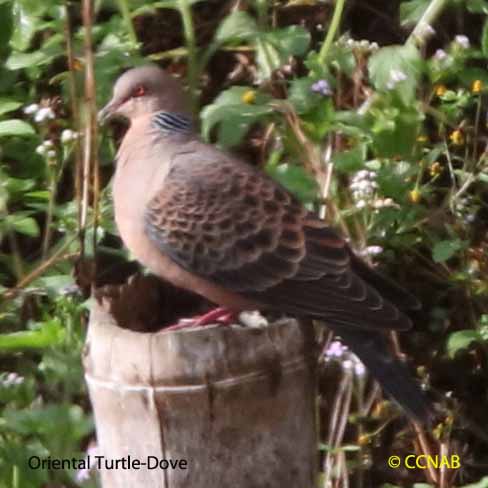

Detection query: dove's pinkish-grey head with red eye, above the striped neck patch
(98, 65), (189, 122)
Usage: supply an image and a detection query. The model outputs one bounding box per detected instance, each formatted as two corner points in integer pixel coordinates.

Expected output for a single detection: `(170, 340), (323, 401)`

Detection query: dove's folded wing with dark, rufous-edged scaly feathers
(145, 143), (418, 330)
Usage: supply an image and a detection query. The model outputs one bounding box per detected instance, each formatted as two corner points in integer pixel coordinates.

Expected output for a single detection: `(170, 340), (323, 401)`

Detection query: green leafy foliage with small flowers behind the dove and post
(0, 0), (488, 488)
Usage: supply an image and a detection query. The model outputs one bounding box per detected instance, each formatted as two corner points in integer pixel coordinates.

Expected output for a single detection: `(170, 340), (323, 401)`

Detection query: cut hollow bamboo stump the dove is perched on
(84, 278), (317, 488)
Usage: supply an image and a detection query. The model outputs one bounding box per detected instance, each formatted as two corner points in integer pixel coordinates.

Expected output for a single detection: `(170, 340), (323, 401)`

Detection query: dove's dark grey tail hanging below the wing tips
(332, 326), (433, 424)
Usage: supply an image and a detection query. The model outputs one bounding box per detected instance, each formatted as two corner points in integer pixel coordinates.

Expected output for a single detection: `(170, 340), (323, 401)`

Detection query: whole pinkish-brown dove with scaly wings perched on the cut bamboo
(99, 65), (431, 422)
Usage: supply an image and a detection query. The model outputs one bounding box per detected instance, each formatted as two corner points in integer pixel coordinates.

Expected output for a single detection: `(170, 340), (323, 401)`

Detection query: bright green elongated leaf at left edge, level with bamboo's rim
(0, 319), (65, 351)
